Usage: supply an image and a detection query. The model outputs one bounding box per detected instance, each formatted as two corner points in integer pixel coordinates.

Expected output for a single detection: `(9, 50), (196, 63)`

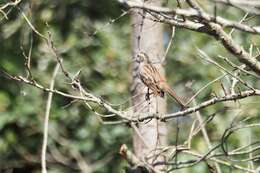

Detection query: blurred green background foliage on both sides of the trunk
(0, 0), (260, 173)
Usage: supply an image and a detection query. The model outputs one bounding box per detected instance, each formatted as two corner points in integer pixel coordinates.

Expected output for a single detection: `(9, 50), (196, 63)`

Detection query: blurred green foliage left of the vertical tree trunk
(0, 0), (131, 172)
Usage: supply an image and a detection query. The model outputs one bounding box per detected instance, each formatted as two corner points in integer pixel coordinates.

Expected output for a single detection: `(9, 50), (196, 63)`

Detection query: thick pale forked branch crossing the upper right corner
(119, 1), (260, 74)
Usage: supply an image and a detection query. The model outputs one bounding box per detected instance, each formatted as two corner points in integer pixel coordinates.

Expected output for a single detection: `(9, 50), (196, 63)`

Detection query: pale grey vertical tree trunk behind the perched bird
(131, 0), (167, 172)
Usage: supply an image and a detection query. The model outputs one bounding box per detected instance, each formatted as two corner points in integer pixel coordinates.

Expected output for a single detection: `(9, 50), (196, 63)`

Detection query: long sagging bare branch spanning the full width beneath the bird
(1, 66), (260, 123)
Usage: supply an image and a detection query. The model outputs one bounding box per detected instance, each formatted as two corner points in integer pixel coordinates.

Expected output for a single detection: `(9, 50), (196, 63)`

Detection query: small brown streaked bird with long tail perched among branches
(136, 52), (185, 108)
